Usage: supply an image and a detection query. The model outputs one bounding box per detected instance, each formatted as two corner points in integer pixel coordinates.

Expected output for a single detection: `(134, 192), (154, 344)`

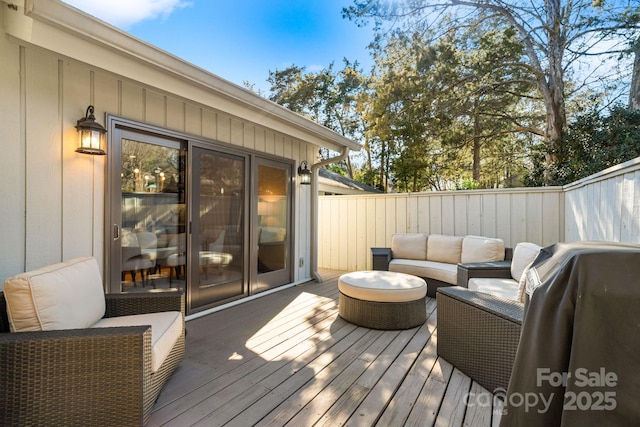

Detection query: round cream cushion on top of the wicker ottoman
(338, 271), (427, 302)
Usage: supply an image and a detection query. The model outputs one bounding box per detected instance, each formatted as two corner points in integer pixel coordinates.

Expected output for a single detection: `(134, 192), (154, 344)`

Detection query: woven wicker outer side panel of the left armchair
(0, 326), (151, 426)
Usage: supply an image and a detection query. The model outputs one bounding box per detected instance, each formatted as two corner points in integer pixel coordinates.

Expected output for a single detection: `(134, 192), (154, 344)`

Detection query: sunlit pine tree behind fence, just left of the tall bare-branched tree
(440, 17), (539, 188)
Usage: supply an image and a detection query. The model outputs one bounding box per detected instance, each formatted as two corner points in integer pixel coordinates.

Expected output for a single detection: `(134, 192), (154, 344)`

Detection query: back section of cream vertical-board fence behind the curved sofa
(318, 187), (565, 270)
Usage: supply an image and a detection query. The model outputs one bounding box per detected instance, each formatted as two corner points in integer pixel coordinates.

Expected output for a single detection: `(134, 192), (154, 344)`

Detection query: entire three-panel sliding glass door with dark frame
(110, 123), (293, 313)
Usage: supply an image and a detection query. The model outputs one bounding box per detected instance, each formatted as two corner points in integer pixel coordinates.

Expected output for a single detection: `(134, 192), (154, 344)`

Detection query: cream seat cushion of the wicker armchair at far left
(92, 311), (182, 372)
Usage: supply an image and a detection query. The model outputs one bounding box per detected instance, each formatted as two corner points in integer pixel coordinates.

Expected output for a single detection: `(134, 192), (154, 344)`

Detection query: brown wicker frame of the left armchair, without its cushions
(0, 292), (185, 426)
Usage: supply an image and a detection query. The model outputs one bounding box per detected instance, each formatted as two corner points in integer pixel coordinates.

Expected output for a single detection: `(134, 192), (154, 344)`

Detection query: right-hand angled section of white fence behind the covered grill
(564, 158), (640, 243)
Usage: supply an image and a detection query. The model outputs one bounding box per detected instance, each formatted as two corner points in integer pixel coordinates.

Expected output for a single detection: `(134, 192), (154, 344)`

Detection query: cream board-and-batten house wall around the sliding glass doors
(0, 3), (318, 283)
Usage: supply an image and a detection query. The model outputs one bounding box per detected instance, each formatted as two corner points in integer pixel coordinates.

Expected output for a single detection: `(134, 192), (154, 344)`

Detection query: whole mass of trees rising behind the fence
(268, 0), (640, 191)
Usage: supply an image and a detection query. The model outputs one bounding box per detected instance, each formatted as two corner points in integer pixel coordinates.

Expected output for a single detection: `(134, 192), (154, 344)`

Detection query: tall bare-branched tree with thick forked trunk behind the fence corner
(343, 0), (640, 183)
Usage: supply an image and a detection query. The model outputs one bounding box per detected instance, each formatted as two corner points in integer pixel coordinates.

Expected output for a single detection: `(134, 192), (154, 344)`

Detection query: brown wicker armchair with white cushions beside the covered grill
(436, 242), (542, 395)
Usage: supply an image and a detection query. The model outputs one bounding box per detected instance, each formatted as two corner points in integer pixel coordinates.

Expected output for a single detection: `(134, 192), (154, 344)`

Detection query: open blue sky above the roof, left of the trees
(64, 0), (373, 91)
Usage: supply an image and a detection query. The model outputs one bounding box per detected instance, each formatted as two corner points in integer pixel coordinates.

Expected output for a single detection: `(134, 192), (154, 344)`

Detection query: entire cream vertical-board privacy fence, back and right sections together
(318, 158), (640, 270)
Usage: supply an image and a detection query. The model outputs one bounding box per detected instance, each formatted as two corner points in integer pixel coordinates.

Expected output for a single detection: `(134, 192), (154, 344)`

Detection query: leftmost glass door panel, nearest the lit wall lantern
(114, 132), (186, 292)
